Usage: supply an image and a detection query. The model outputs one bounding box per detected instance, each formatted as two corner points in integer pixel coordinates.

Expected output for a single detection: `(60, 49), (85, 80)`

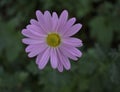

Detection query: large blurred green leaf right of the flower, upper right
(90, 16), (113, 47)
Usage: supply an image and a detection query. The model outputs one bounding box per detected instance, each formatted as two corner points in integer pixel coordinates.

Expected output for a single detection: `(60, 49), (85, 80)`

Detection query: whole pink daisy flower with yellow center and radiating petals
(22, 10), (82, 72)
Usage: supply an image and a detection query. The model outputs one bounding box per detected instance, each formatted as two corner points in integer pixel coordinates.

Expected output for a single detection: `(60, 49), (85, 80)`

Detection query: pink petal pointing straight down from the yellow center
(50, 48), (58, 69)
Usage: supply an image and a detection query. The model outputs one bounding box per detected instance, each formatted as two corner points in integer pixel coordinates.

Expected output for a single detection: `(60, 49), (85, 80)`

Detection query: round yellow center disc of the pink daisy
(46, 33), (61, 47)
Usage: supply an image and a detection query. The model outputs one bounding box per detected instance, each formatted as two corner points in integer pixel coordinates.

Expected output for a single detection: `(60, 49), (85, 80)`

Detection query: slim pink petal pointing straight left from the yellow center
(22, 38), (44, 44)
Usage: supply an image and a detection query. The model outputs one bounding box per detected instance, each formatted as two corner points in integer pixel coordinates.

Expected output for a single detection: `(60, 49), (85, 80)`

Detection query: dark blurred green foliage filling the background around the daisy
(0, 0), (120, 92)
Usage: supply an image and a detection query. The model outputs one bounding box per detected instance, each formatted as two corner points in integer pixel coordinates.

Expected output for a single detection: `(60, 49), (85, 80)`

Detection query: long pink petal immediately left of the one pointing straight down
(38, 48), (50, 69)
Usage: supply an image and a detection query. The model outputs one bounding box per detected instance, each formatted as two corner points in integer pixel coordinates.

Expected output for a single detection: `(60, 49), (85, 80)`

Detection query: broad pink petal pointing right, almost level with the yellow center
(63, 37), (83, 47)
